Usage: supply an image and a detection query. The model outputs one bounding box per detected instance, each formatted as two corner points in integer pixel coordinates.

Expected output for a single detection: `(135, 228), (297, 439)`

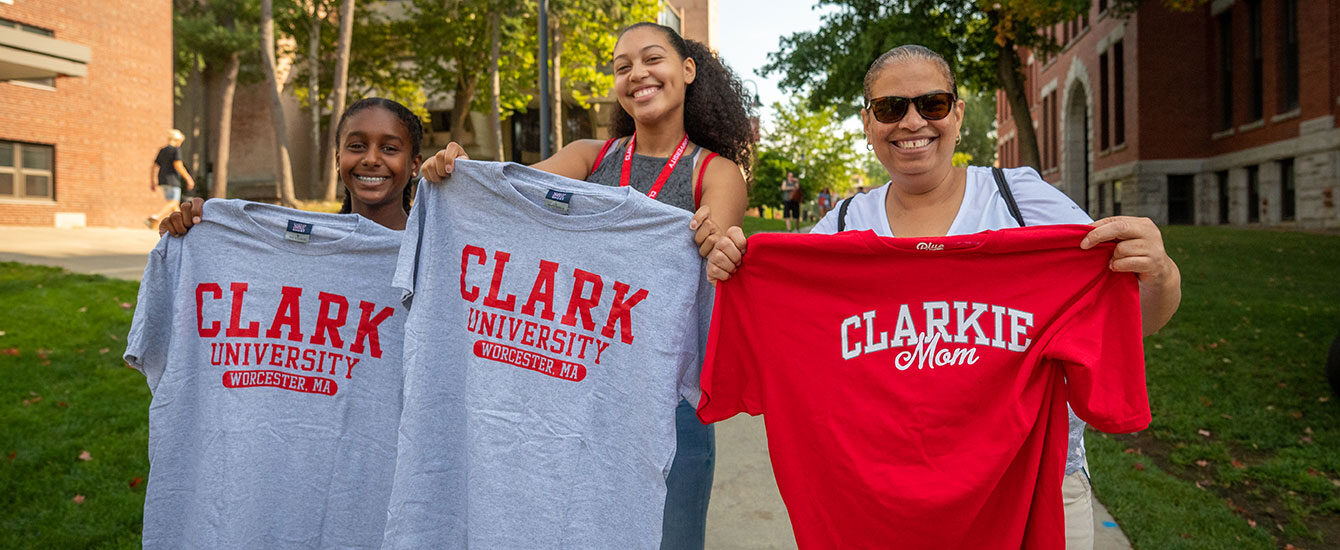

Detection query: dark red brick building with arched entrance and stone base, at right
(996, 0), (1340, 228)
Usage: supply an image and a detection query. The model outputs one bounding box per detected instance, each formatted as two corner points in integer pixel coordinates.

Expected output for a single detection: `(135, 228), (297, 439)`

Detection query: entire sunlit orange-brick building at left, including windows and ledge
(0, 0), (173, 227)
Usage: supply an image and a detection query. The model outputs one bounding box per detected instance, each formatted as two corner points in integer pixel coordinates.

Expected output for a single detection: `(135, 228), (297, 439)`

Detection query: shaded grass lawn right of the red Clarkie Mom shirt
(1087, 227), (1340, 549)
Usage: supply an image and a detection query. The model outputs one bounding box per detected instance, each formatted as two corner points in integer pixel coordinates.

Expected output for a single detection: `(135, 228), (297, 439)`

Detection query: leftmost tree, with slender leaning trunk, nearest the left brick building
(173, 0), (260, 199)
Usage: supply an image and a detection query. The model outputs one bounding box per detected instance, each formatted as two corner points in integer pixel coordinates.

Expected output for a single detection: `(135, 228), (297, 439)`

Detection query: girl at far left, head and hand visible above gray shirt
(158, 98), (423, 236)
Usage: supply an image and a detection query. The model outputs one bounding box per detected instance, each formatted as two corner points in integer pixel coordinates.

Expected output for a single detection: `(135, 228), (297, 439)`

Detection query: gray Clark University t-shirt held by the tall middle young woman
(386, 160), (712, 549)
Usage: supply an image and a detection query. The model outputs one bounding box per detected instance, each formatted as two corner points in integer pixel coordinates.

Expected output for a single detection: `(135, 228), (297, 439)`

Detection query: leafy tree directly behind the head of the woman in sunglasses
(761, 0), (1089, 168)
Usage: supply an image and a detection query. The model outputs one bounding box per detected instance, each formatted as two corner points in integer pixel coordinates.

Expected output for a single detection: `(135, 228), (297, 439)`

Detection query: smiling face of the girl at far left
(335, 107), (419, 212)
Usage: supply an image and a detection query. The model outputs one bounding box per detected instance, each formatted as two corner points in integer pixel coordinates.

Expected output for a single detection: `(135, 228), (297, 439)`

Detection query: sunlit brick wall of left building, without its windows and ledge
(0, 0), (173, 227)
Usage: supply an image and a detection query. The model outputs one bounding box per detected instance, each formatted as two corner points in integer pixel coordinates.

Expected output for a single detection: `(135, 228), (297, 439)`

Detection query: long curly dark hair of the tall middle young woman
(610, 23), (753, 182)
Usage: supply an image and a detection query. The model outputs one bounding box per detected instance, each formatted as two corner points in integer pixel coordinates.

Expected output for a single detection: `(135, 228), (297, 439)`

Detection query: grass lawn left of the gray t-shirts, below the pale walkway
(0, 263), (149, 549)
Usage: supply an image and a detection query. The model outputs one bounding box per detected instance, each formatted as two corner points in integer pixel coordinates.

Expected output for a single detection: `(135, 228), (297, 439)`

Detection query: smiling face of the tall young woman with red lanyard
(614, 27), (697, 123)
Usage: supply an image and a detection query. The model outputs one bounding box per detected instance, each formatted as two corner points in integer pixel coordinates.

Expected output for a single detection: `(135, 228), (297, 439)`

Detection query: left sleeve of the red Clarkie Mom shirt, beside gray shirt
(698, 274), (764, 424)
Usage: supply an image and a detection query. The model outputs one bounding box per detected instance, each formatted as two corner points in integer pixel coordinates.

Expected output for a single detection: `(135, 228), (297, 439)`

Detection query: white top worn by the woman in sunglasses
(809, 166), (1093, 475)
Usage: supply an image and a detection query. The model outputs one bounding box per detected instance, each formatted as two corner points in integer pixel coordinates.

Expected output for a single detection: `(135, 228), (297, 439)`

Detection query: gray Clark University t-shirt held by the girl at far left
(125, 200), (405, 549)
